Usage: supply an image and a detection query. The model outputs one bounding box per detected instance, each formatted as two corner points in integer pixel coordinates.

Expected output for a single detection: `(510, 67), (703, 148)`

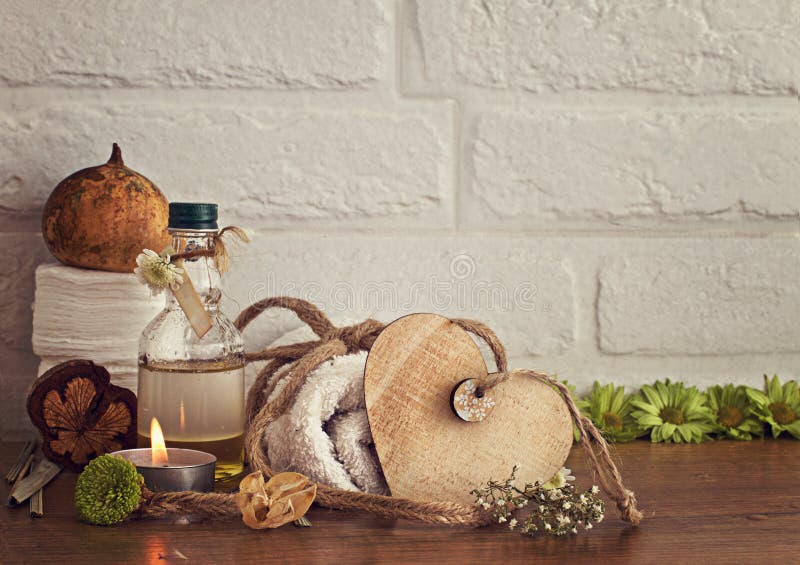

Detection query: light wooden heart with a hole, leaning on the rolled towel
(364, 314), (572, 504)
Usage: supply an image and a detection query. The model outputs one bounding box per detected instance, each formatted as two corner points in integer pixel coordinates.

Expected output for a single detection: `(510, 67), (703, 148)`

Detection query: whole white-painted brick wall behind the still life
(0, 0), (800, 436)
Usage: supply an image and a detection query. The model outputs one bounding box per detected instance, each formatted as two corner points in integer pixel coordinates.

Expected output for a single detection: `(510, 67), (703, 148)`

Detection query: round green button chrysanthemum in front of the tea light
(75, 455), (144, 526)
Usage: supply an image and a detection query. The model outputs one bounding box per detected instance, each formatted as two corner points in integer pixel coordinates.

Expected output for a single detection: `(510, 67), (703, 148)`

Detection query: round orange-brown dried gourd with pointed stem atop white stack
(42, 143), (171, 272)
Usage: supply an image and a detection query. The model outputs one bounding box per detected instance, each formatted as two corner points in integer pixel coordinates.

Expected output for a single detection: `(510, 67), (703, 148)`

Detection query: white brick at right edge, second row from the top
(462, 111), (800, 227)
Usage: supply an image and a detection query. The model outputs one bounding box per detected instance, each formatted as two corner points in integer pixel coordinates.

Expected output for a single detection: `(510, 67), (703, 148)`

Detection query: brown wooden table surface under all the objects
(0, 439), (800, 564)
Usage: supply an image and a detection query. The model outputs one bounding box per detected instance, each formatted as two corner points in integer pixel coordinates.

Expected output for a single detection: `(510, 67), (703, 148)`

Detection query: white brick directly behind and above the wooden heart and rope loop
(226, 234), (576, 355)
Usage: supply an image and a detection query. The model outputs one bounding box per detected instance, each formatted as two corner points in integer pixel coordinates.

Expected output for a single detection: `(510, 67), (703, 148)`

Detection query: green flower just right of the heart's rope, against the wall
(581, 381), (645, 443)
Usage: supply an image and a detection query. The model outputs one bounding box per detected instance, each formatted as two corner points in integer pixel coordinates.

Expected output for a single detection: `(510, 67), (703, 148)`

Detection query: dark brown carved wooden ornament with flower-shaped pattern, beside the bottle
(28, 360), (136, 471)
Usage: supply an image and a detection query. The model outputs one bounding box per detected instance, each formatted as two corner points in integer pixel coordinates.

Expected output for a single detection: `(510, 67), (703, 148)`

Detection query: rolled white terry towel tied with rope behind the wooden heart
(262, 327), (389, 494)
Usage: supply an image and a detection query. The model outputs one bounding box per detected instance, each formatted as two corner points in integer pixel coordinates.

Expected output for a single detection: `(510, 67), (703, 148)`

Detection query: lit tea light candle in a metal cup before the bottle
(112, 418), (217, 492)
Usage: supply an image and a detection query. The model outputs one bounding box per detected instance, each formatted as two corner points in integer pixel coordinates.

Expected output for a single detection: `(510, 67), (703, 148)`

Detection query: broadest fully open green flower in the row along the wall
(631, 379), (714, 443)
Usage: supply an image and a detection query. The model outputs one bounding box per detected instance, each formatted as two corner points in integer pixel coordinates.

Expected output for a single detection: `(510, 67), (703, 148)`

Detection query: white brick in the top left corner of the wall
(0, 0), (390, 89)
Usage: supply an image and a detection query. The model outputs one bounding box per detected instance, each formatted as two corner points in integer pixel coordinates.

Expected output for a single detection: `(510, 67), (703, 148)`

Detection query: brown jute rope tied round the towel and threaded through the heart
(140, 296), (642, 527)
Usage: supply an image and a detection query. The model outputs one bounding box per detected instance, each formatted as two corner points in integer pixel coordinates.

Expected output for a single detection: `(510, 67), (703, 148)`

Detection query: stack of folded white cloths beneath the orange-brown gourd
(33, 263), (164, 392)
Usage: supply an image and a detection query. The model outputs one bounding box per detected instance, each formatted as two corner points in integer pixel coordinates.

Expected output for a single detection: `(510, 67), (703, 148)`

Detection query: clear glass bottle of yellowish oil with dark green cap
(137, 202), (244, 480)
